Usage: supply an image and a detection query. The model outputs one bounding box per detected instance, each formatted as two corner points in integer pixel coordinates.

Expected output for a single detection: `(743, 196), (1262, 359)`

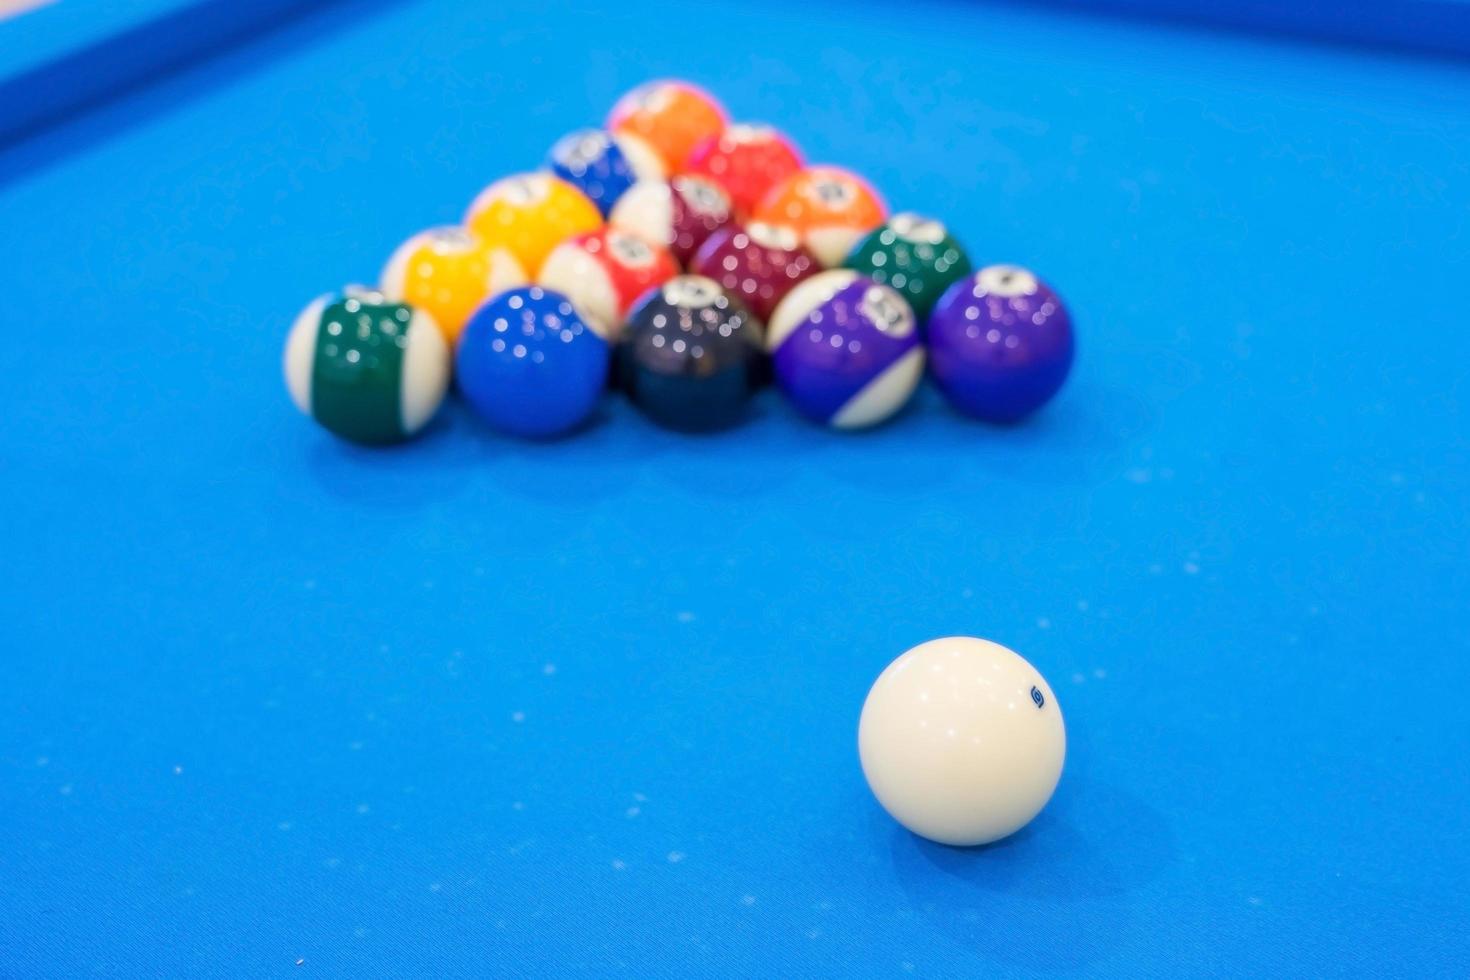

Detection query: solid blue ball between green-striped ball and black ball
(454, 287), (612, 438)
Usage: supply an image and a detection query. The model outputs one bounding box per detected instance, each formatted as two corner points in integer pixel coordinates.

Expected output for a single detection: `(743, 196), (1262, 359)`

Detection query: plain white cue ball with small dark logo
(857, 636), (1067, 846)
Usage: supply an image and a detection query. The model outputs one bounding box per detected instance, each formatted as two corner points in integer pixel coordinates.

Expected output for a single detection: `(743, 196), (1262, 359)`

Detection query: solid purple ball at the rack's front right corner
(928, 266), (1073, 422)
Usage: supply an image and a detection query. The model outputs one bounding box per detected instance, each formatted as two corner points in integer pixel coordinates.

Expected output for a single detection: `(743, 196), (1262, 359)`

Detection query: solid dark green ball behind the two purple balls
(842, 213), (970, 320)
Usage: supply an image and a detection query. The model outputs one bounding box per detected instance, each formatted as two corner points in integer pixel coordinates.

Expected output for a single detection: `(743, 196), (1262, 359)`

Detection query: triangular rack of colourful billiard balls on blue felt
(285, 81), (1073, 444)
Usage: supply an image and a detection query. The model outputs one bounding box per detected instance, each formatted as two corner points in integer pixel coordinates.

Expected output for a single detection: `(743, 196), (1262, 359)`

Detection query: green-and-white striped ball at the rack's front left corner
(285, 287), (450, 445)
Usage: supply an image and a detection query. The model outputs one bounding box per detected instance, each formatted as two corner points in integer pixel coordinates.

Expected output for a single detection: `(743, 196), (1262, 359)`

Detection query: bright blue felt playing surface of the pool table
(0, 1), (1470, 977)
